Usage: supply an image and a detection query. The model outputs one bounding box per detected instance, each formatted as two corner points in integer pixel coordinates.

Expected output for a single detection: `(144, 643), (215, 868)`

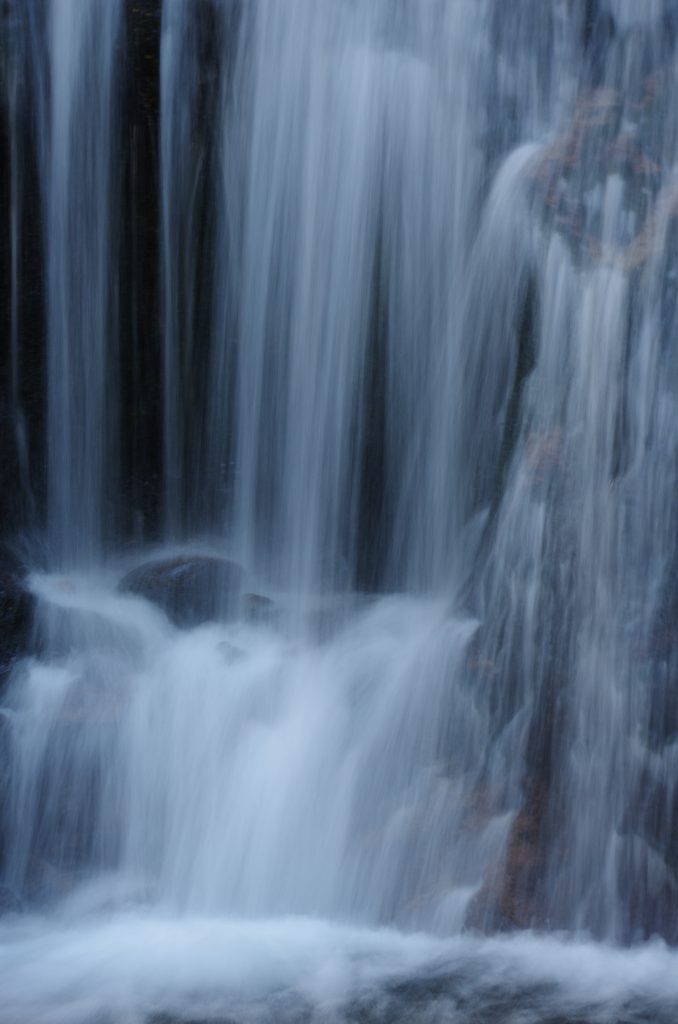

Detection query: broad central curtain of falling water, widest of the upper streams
(212, 2), (493, 590)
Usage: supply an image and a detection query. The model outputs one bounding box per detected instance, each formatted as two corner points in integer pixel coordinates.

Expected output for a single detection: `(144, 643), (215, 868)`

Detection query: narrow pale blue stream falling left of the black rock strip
(41, 0), (122, 564)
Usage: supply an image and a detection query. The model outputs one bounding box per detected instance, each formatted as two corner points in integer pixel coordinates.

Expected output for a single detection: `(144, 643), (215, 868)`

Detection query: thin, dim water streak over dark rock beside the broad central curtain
(160, 0), (231, 540)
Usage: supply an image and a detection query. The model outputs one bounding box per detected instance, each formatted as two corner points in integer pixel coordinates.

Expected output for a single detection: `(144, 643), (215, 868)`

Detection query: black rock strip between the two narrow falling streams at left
(118, 0), (163, 543)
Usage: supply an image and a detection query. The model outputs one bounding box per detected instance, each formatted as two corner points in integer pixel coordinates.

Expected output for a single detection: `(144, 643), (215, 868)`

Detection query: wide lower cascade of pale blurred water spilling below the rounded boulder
(7, 579), (493, 931)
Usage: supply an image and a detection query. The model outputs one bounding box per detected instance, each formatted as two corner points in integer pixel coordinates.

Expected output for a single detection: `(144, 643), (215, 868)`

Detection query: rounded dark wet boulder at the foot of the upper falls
(119, 555), (244, 628)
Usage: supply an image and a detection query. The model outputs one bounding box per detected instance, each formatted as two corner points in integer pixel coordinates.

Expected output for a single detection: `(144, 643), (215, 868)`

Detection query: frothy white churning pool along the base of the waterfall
(0, 909), (678, 1024)
